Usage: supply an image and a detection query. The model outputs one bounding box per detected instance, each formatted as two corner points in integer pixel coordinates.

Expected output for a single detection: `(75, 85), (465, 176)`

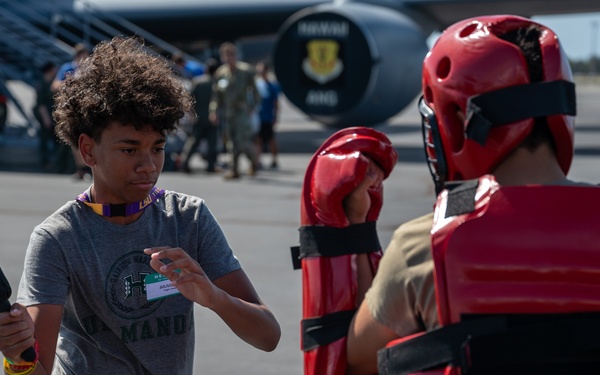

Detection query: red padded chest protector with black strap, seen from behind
(379, 176), (600, 374)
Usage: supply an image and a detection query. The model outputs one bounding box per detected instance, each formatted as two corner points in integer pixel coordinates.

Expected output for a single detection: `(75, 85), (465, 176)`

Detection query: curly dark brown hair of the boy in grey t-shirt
(53, 37), (193, 148)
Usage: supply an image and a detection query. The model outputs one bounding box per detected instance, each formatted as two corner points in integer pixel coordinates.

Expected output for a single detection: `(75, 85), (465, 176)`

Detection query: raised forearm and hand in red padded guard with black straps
(299, 127), (398, 375)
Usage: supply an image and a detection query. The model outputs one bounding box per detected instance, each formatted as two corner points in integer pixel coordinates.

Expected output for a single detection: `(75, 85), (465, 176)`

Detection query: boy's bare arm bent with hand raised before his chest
(144, 247), (281, 351)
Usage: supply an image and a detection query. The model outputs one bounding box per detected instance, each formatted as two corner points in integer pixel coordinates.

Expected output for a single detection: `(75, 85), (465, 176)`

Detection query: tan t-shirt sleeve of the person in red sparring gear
(365, 213), (439, 337)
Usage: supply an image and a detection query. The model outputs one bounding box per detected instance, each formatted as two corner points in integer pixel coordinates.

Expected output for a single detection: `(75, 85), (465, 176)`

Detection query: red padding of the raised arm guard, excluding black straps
(301, 127), (398, 375)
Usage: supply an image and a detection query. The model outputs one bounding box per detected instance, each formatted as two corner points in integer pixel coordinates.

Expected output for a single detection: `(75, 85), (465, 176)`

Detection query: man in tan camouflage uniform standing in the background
(209, 42), (260, 179)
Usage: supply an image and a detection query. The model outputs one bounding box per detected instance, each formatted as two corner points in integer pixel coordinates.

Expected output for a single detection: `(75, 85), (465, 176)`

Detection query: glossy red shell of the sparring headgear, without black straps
(420, 15), (575, 189)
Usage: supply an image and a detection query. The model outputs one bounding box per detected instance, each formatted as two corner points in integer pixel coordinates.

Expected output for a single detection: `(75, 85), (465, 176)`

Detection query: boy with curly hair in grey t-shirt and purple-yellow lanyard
(0, 38), (280, 374)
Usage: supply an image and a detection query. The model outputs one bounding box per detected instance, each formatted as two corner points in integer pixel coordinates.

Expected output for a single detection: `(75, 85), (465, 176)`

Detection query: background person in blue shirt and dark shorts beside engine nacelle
(256, 61), (281, 168)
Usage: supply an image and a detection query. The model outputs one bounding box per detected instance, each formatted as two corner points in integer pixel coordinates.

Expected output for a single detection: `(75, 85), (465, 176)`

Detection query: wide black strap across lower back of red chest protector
(378, 313), (600, 375)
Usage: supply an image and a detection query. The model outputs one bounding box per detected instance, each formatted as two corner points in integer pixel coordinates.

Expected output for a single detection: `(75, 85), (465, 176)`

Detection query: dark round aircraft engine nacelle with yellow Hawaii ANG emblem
(273, 3), (428, 128)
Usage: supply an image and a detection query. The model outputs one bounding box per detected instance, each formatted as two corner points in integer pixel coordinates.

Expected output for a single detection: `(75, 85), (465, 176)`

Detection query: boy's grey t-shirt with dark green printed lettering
(17, 191), (241, 375)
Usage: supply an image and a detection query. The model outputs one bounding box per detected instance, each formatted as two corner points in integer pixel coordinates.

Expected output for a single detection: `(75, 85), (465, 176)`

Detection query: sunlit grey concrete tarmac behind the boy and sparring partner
(0, 85), (600, 375)
